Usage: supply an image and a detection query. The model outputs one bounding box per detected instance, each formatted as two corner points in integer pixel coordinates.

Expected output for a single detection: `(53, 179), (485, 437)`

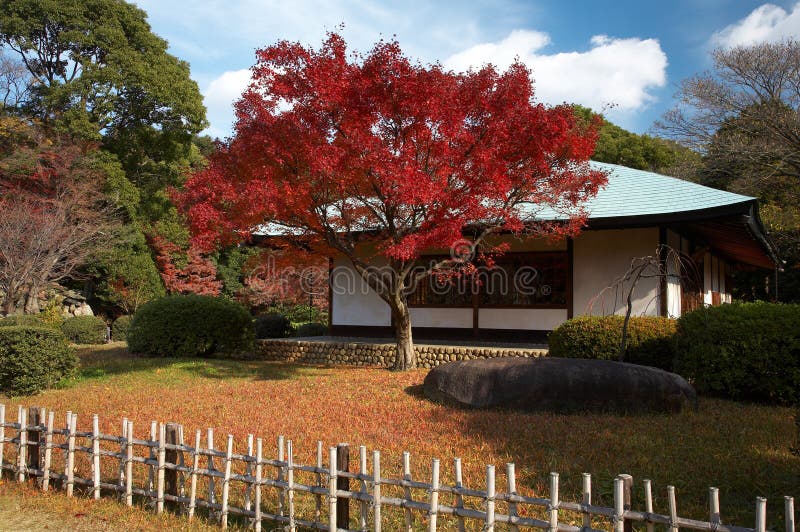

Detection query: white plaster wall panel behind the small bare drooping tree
(573, 227), (660, 316)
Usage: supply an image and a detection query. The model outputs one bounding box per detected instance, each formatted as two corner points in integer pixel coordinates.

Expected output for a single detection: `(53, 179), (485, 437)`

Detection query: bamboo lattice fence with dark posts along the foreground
(0, 404), (795, 532)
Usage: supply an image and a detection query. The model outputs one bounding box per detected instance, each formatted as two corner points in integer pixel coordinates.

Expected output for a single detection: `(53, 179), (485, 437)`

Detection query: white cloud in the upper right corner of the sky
(711, 2), (800, 48)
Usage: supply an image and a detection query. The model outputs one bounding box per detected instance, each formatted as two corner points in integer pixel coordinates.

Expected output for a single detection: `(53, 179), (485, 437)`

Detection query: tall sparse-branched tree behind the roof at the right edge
(656, 40), (800, 301)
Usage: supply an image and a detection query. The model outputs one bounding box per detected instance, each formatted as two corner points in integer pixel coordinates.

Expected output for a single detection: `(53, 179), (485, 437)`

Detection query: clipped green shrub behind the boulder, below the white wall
(547, 316), (675, 371)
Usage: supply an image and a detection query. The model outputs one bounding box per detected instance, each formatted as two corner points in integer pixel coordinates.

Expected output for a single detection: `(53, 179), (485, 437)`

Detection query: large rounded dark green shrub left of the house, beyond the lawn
(128, 295), (253, 357)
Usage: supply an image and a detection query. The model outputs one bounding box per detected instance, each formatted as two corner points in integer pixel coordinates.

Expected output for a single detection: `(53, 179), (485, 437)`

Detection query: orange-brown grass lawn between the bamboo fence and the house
(0, 345), (800, 529)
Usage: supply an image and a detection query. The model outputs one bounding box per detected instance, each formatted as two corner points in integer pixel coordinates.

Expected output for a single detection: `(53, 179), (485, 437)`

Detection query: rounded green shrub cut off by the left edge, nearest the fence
(0, 326), (78, 395)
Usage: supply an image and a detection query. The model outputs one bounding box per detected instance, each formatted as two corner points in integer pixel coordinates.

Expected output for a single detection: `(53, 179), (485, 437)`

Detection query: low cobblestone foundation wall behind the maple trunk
(256, 339), (547, 368)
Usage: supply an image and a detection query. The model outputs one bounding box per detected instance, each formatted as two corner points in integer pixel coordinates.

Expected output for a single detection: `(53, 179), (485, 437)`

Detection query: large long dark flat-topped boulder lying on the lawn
(424, 357), (697, 412)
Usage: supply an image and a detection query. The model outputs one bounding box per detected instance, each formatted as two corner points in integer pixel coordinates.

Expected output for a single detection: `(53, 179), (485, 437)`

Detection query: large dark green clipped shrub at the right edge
(675, 303), (800, 404)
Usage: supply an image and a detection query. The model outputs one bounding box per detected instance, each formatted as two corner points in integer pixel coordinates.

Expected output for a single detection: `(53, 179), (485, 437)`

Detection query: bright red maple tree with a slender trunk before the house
(178, 33), (605, 369)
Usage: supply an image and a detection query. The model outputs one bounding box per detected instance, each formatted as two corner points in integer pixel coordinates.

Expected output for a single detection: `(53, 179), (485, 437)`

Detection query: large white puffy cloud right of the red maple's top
(445, 30), (667, 114)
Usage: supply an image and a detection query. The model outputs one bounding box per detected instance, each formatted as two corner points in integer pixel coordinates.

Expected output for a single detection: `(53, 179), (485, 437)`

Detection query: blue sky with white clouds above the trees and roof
(135, 0), (800, 137)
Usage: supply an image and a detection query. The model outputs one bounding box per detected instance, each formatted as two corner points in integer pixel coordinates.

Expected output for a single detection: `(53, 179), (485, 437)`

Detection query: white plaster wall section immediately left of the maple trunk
(331, 259), (392, 327)
